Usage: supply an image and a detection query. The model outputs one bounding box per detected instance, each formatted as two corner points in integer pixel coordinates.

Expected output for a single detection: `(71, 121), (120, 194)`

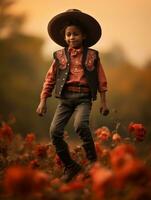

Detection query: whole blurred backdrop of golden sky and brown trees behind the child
(0, 0), (151, 142)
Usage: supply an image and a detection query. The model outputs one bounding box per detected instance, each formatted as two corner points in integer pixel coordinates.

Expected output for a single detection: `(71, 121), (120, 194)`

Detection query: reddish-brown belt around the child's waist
(65, 85), (90, 93)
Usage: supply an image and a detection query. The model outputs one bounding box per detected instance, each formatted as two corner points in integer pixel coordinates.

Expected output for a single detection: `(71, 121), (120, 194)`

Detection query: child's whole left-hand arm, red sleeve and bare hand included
(36, 60), (56, 116)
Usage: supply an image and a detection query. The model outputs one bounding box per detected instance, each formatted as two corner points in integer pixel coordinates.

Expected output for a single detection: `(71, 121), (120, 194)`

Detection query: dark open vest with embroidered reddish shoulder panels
(54, 48), (98, 100)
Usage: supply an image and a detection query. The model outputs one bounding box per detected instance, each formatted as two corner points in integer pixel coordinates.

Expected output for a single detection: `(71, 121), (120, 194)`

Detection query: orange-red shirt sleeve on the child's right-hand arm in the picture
(98, 59), (107, 92)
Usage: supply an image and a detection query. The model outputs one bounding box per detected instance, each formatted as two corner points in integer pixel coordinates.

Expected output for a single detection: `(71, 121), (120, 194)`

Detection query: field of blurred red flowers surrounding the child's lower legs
(0, 119), (151, 200)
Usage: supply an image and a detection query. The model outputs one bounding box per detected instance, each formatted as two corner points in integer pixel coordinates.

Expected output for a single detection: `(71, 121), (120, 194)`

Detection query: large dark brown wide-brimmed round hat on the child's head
(48, 9), (102, 47)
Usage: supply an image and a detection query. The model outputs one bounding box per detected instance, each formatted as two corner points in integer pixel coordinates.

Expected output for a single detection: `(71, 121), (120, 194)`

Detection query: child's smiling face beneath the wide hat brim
(65, 25), (86, 48)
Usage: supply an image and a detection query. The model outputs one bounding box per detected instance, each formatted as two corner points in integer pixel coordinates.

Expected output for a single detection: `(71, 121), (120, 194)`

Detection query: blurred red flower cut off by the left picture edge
(0, 124), (14, 143)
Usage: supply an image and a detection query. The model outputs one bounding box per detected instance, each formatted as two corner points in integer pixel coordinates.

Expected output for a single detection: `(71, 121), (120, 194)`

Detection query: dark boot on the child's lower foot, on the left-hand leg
(57, 149), (82, 182)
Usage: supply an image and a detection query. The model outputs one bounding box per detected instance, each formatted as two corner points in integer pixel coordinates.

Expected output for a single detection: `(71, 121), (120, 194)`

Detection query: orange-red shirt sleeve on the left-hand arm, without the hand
(40, 59), (57, 99)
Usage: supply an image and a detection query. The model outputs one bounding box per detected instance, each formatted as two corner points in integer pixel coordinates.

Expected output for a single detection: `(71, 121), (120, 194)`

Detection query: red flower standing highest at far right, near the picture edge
(128, 123), (146, 141)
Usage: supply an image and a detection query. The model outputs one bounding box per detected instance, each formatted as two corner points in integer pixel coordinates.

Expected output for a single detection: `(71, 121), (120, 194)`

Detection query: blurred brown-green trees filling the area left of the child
(0, 0), (53, 138)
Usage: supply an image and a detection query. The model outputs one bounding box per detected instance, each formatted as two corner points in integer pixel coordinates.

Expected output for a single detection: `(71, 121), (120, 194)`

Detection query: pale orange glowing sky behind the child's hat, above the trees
(13, 0), (151, 67)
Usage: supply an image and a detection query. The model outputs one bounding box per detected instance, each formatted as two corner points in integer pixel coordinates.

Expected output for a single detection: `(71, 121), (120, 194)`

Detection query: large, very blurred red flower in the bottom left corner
(4, 166), (49, 196)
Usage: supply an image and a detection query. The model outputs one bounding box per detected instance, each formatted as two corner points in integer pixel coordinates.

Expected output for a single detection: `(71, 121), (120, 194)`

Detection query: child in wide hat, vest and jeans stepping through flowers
(37, 9), (109, 182)
